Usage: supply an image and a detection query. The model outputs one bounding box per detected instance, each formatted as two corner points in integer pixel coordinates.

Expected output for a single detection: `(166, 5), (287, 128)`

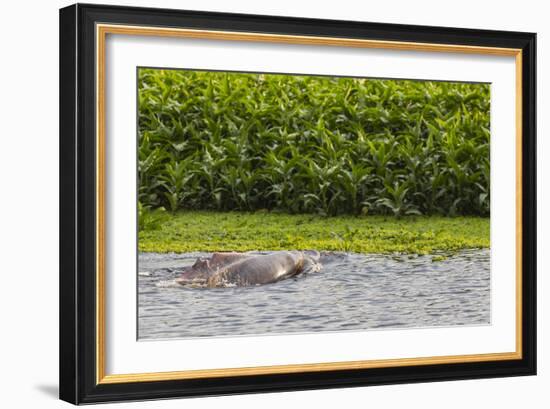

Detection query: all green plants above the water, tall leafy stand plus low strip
(138, 69), (490, 218)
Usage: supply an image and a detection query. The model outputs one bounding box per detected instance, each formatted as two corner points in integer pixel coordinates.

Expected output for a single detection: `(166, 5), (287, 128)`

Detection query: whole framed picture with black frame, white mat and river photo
(60, 5), (536, 404)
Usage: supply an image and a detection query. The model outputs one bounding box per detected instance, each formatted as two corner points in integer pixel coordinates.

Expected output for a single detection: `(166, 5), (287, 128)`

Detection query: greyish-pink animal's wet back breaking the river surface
(176, 251), (321, 288)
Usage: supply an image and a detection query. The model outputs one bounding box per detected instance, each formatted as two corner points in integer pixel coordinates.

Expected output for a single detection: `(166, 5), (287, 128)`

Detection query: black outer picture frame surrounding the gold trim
(59, 4), (536, 404)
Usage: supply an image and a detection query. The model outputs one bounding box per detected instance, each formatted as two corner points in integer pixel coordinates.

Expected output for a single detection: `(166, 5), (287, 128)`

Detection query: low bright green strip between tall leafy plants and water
(139, 211), (489, 254)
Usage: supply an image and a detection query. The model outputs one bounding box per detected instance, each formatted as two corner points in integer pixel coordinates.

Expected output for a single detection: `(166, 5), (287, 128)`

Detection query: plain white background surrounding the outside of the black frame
(0, 0), (550, 409)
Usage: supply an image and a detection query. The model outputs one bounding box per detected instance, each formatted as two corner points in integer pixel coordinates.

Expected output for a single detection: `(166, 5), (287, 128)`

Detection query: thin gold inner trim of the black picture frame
(96, 24), (523, 384)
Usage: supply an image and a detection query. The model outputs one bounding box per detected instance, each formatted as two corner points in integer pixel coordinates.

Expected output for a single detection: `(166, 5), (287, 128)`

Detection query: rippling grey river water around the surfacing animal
(138, 250), (490, 340)
